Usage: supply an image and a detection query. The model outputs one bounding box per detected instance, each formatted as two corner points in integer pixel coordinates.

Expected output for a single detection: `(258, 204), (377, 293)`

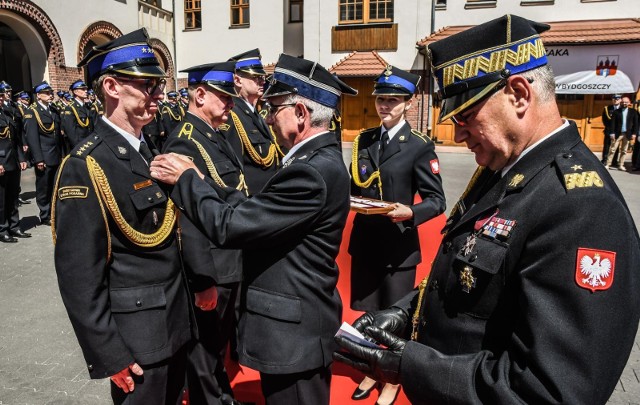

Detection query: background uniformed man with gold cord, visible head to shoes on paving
(24, 82), (62, 226)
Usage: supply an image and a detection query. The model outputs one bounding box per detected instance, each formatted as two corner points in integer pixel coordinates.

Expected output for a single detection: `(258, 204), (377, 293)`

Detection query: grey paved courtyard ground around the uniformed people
(0, 148), (640, 405)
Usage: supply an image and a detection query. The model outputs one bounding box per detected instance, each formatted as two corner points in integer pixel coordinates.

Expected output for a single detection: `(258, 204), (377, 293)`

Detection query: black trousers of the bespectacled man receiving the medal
(111, 345), (188, 405)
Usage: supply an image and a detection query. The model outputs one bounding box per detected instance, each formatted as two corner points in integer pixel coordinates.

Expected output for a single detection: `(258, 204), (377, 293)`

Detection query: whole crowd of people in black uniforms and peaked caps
(0, 11), (640, 405)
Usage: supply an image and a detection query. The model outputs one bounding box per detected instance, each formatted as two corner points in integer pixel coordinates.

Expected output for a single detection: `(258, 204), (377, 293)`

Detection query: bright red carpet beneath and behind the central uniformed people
(227, 208), (446, 405)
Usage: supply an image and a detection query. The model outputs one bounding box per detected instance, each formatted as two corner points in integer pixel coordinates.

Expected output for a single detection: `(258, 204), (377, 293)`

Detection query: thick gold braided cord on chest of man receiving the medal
(87, 156), (176, 247)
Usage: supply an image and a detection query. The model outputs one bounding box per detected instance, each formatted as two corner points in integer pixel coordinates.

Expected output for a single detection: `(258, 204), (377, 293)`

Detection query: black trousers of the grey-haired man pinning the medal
(260, 367), (331, 405)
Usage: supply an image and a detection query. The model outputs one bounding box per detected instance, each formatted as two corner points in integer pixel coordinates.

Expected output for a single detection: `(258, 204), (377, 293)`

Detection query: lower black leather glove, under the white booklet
(333, 326), (407, 384)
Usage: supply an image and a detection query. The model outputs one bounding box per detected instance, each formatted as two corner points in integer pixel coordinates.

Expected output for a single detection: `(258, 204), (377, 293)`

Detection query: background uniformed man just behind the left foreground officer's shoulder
(62, 80), (93, 149)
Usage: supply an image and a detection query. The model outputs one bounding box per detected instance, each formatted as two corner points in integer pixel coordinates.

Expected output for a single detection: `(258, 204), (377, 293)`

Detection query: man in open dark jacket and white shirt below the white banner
(605, 96), (638, 171)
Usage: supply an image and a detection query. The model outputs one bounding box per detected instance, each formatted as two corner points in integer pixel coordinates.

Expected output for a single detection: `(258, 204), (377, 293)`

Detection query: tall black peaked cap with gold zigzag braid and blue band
(428, 14), (549, 121)
